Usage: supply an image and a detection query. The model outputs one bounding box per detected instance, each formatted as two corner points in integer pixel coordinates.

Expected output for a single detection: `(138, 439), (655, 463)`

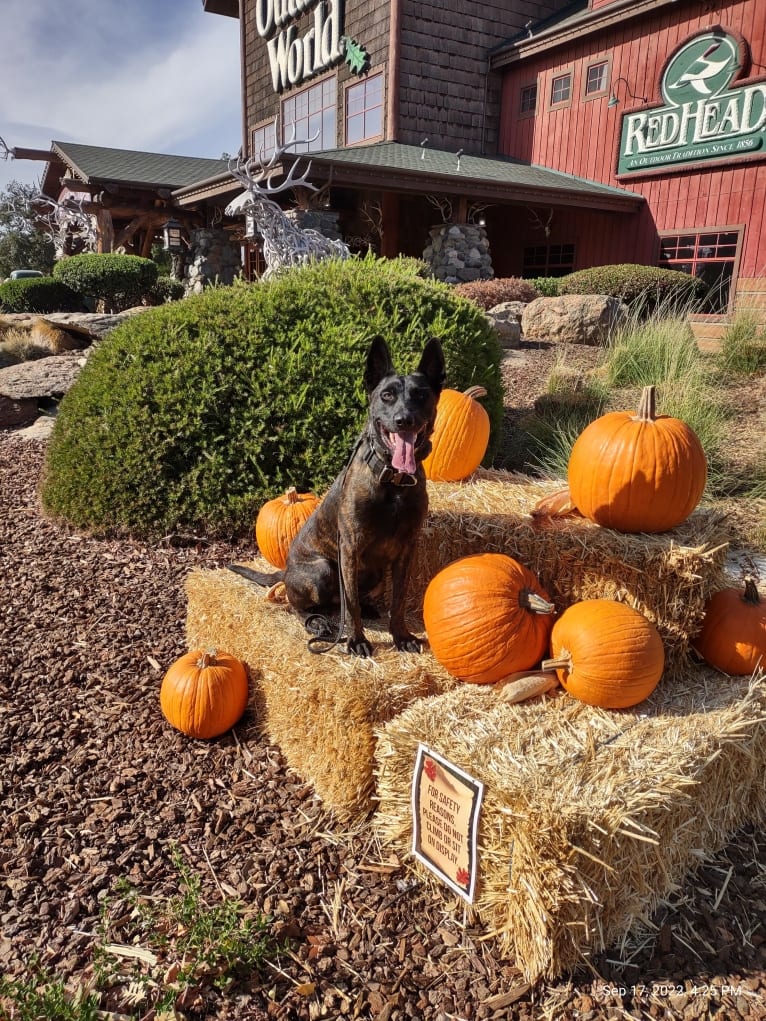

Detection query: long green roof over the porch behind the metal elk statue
(302, 142), (643, 207)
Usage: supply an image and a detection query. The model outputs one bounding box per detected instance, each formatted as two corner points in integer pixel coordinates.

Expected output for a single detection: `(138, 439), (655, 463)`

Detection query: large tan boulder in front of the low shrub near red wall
(521, 294), (627, 345)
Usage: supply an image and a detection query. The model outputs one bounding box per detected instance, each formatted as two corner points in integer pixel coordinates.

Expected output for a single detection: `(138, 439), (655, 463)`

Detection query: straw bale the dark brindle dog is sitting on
(186, 561), (458, 818)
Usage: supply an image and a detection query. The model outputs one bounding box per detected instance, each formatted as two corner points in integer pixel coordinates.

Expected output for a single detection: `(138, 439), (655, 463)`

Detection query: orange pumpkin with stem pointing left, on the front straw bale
(542, 599), (665, 709)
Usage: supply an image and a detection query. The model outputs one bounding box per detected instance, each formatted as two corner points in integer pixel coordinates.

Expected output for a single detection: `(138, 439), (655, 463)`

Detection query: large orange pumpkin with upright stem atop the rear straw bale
(567, 386), (707, 532)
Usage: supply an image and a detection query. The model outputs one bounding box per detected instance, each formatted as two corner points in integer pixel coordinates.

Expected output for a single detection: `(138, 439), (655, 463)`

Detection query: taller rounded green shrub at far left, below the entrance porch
(53, 253), (157, 312)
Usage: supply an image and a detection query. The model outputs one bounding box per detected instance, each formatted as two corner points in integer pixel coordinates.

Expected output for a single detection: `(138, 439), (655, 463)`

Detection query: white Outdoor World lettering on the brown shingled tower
(255, 0), (343, 92)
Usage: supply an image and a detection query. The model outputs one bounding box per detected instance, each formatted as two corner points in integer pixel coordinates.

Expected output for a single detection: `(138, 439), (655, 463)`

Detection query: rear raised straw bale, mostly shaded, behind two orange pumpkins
(411, 470), (729, 673)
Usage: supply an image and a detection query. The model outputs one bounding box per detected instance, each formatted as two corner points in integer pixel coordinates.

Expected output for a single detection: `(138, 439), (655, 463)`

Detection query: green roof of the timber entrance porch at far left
(51, 142), (229, 188)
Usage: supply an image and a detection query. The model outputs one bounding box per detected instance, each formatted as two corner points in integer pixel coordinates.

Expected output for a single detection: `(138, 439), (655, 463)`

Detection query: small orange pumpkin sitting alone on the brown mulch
(159, 649), (247, 738)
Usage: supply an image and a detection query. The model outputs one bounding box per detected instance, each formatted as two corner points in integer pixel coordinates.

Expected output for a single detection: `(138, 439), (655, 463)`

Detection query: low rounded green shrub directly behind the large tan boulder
(559, 262), (706, 314)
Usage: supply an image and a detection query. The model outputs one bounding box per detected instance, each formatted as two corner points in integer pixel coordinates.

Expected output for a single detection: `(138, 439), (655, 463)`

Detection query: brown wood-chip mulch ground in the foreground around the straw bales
(0, 350), (766, 1021)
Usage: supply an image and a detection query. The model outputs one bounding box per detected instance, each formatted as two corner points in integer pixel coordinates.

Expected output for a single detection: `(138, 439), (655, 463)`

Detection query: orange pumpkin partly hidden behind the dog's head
(423, 386), (489, 482)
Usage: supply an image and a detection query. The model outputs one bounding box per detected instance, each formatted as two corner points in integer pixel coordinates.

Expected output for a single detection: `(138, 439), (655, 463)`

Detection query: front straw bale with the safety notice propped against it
(373, 668), (766, 981)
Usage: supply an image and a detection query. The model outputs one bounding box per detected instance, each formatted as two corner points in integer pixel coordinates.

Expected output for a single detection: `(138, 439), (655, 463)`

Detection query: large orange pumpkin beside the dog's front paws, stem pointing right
(423, 553), (555, 684)
